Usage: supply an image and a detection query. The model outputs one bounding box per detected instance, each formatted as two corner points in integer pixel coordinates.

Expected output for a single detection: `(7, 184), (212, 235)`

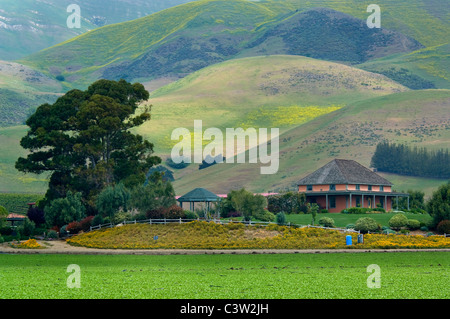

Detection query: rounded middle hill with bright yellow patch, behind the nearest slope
(137, 55), (408, 154)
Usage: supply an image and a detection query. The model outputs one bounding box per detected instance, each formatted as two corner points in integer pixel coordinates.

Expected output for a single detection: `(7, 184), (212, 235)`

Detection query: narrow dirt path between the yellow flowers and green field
(0, 240), (450, 255)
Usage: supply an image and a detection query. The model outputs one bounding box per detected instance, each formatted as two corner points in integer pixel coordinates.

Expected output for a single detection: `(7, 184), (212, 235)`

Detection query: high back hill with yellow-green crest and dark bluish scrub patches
(19, 0), (430, 87)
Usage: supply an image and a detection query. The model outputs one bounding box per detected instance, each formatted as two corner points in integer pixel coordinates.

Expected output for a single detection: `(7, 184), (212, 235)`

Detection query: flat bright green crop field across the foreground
(0, 252), (450, 299)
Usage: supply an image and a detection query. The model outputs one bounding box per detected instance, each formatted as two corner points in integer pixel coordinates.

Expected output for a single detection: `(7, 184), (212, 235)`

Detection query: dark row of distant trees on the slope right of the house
(371, 142), (450, 178)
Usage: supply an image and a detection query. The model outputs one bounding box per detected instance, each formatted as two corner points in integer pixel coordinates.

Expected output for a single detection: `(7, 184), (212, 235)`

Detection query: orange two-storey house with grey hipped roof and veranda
(297, 159), (409, 213)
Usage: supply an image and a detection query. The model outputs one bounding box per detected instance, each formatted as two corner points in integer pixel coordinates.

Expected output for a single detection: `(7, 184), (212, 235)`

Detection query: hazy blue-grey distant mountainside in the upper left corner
(0, 0), (190, 60)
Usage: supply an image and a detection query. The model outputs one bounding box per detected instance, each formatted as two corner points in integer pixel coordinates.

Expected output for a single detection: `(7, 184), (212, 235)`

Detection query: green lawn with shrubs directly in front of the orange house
(286, 213), (432, 228)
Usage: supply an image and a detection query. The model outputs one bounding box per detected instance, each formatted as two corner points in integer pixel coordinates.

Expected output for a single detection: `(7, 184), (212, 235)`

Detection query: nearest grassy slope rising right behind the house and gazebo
(174, 90), (450, 195)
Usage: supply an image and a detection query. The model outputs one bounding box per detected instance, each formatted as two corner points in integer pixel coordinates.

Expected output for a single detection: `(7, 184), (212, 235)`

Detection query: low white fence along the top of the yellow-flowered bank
(90, 218), (360, 234)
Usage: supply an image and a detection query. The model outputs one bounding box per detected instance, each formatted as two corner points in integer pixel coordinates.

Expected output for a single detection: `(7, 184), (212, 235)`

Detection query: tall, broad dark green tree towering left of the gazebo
(16, 80), (161, 207)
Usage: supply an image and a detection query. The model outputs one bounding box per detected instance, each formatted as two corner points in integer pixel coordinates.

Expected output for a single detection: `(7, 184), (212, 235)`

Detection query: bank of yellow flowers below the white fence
(67, 221), (450, 249)
